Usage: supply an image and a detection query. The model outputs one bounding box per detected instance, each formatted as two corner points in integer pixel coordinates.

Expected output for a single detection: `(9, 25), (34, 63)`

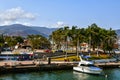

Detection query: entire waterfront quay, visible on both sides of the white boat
(0, 59), (120, 74)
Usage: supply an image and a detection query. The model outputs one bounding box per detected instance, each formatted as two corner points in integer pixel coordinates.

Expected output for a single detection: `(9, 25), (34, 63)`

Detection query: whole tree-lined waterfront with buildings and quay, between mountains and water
(0, 24), (120, 73)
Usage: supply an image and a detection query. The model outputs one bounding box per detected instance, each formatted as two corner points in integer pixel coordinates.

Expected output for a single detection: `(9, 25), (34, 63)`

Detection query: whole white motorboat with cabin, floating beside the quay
(73, 57), (103, 74)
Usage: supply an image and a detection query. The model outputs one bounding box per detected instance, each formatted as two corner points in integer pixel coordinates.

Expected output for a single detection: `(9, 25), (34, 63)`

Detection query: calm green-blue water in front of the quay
(0, 68), (120, 80)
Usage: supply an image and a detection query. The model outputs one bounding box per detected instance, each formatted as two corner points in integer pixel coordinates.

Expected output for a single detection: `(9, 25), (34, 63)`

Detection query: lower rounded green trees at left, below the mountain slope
(0, 35), (50, 49)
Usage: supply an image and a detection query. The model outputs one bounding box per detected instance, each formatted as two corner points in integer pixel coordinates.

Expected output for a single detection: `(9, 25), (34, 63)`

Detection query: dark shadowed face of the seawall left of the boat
(0, 64), (73, 74)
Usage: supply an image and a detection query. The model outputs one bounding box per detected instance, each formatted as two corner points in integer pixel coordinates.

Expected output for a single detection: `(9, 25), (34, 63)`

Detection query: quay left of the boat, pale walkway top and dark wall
(0, 61), (74, 74)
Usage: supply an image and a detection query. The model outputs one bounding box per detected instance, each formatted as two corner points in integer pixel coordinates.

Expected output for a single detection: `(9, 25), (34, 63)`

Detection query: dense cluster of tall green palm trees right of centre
(50, 24), (117, 51)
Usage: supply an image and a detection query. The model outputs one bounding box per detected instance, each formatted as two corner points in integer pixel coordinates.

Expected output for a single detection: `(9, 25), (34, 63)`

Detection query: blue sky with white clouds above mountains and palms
(0, 0), (120, 29)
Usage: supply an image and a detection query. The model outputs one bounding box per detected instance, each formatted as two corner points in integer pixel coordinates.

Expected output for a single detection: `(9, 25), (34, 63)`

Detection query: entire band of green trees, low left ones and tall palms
(0, 24), (117, 51)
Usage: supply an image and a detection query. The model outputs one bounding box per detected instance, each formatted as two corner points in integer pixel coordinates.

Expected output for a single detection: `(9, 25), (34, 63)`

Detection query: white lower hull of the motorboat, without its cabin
(73, 66), (102, 74)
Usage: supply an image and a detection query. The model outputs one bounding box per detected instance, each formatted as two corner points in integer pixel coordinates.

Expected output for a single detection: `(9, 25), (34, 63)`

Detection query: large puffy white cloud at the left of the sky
(0, 7), (36, 25)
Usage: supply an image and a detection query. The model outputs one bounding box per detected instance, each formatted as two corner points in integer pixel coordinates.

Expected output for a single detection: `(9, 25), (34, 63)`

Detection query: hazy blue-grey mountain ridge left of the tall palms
(0, 24), (57, 37)
